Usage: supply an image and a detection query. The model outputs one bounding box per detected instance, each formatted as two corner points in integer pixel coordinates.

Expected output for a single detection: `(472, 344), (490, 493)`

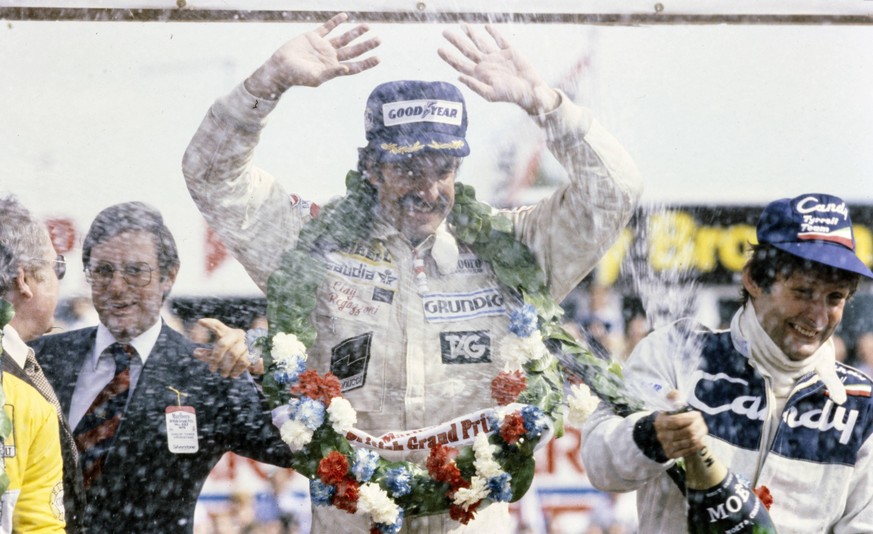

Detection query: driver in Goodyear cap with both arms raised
(183, 14), (641, 532)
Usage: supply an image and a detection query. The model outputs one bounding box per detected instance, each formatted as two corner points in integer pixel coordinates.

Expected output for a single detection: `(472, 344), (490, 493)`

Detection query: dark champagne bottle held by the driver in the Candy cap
(685, 447), (776, 534)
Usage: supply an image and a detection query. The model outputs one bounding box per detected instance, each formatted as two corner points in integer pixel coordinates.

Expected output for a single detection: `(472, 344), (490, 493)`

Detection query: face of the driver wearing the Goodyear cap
(369, 155), (461, 244)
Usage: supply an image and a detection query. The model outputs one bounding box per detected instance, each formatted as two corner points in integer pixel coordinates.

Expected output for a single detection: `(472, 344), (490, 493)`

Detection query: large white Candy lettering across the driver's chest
(689, 371), (858, 445)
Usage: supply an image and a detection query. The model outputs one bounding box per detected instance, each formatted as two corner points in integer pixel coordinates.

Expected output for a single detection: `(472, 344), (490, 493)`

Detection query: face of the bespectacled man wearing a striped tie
(88, 231), (177, 341)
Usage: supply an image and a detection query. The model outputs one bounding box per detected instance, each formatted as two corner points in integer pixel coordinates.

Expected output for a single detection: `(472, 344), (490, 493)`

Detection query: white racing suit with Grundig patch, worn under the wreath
(183, 81), (641, 532)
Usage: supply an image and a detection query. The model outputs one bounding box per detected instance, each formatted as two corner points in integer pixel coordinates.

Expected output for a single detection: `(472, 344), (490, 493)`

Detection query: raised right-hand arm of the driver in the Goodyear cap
(439, 26), (642, 301)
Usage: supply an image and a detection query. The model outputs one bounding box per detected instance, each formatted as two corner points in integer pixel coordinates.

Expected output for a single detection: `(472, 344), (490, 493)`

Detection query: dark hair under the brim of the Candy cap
(740, 243), (861, 304)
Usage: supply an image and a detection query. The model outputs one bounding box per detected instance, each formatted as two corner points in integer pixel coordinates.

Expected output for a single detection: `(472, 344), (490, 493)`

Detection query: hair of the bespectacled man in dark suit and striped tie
(82, 202), (181, 277)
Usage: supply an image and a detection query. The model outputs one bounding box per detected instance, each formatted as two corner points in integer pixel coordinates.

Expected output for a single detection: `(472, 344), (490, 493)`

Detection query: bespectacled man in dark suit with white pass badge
(30, 202), (291, 533)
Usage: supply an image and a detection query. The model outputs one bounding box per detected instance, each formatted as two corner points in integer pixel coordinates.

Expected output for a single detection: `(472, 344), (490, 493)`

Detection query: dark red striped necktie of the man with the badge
(73, 343), (136, 488)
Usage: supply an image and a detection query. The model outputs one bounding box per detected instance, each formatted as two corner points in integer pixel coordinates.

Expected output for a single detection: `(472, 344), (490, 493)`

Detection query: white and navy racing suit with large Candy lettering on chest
(582, 320), (873, 534)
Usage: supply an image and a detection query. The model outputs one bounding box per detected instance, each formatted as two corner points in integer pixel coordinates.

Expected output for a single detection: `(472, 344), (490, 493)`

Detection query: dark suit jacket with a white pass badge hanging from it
(33, 325), (291, 534)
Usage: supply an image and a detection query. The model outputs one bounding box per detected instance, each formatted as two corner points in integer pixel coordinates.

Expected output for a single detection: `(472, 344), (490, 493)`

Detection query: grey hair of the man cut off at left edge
(0, 195), (51, 296)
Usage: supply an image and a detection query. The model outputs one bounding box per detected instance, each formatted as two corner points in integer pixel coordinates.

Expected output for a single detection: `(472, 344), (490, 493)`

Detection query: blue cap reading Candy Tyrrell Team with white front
(757, 193), (873, 278)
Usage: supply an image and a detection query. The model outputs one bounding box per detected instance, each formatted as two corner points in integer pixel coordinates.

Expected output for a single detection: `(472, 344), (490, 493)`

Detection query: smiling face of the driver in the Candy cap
(743, 270), (852, 361)
